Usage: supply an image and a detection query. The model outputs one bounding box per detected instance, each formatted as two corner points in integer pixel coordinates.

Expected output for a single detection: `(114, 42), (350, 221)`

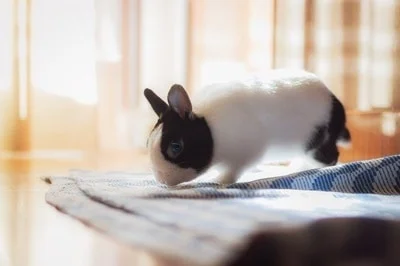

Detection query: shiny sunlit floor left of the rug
(0, 154), (189, 266)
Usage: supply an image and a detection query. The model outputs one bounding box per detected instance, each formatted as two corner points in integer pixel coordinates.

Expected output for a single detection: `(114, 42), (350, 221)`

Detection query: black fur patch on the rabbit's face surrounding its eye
(158, 110), (213, 173)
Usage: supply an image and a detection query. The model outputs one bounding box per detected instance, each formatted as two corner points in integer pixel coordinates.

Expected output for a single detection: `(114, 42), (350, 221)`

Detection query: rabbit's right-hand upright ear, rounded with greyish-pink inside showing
(168, 84), (192, 119)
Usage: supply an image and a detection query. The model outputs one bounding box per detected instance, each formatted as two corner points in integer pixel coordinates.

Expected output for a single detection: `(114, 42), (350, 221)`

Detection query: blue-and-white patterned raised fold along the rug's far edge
(145, 155), (400, 198)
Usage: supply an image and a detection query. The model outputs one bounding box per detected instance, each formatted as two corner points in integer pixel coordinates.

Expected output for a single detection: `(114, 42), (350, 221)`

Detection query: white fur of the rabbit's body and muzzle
(150, 70), (346, 185)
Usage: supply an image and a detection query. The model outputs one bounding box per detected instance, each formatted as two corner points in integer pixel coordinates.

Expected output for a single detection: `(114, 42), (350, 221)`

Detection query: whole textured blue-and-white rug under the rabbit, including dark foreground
(46, 155), (400, 266)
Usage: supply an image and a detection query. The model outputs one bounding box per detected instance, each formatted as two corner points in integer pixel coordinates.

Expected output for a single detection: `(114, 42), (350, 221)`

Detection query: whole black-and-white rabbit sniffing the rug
(144, 69), (351, 186)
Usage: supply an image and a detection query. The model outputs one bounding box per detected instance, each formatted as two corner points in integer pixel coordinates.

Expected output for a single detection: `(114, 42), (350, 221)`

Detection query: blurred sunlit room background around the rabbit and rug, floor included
(0, 0), (400, 266)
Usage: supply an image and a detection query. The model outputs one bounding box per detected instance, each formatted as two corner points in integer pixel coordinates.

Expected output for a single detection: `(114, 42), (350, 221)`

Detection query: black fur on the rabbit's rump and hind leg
(306, 94), (350, 165)
